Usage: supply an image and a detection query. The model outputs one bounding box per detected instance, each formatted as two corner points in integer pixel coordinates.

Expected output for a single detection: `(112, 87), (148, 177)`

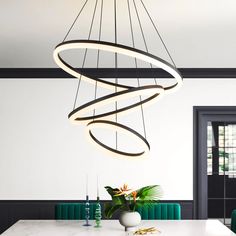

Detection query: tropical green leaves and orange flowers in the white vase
(104, 184), (162, 218)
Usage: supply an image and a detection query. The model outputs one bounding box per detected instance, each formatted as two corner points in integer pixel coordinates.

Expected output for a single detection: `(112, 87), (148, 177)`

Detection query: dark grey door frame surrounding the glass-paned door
(193, 106), (236, 219)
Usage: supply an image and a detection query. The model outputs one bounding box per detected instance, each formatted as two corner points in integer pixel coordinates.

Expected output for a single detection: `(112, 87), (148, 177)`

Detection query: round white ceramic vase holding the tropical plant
(119, 211), (141, 231)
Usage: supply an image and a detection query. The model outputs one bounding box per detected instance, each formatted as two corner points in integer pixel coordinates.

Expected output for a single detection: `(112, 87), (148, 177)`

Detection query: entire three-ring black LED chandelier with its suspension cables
(53, 0), (183, 158)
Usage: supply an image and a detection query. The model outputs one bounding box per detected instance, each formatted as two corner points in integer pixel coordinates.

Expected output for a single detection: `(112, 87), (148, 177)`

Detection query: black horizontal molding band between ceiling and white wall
(0, 68), (236, 79)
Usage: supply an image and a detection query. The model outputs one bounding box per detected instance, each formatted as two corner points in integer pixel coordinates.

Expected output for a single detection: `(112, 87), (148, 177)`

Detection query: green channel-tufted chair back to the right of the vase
(137, 203), (181, 220)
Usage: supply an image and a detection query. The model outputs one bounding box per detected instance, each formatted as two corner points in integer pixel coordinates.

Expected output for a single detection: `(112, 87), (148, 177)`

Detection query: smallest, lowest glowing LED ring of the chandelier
(87, 120), (150, 157)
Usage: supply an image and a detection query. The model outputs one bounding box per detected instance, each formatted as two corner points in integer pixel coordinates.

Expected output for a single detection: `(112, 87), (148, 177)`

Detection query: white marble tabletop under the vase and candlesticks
(1, 220), (235, 236)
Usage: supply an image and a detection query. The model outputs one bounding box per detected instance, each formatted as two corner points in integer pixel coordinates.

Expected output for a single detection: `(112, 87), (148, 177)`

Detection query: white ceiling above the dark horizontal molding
(0, 0), (236, 68)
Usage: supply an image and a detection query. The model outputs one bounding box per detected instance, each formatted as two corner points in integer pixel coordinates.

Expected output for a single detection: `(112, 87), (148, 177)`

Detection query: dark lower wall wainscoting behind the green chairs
(0, 200), (193, 234)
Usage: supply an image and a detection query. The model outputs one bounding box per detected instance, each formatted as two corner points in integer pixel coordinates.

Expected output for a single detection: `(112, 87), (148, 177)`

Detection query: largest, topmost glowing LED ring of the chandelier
(53, 40), (183, 92)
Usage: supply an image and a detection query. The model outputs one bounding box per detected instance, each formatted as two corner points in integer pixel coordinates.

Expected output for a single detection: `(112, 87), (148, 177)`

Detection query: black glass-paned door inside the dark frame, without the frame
(207, 121), (236, 224)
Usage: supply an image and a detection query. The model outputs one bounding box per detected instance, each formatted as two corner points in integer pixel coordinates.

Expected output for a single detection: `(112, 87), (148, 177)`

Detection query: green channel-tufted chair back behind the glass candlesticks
(55, 203), (96, 220)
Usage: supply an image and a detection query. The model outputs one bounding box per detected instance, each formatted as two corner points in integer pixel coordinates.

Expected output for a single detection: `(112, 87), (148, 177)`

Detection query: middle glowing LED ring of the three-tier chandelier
(68, 85), (164, 122)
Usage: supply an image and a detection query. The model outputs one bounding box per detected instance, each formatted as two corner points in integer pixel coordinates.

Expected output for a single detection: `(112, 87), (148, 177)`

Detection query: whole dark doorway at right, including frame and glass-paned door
(193, 106), (236, 223)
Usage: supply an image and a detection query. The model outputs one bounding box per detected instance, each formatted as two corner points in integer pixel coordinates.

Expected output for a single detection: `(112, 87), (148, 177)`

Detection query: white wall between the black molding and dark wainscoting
(0, 79), (236, 200)
